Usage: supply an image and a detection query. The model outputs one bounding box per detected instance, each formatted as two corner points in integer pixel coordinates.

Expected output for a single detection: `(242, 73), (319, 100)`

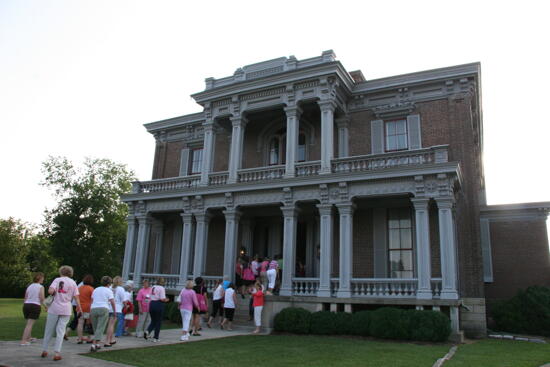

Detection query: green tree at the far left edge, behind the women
(0, 218), (31, 297)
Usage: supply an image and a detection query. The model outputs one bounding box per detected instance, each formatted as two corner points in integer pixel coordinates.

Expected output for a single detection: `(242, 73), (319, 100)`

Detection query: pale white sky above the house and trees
(0, 0), (550, 227)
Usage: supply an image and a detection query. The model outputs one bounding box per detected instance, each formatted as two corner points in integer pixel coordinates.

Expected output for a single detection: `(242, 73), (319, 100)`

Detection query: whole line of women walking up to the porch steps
(21, 259), (270, 361)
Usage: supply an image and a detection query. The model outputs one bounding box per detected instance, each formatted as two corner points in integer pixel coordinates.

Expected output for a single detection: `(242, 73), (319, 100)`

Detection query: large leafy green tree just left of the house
(42, 157), (134, 280)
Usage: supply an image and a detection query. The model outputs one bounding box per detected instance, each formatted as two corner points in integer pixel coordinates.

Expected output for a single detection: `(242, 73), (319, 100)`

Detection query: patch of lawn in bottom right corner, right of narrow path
(445, 339), (550, 367)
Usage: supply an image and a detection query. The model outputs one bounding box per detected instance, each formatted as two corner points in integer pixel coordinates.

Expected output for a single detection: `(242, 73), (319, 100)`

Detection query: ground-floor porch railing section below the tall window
(351, 278), (418, 298)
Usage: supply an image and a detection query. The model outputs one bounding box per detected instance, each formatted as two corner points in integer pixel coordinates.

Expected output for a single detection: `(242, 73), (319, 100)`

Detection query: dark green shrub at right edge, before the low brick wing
(491, 286), (550, 336)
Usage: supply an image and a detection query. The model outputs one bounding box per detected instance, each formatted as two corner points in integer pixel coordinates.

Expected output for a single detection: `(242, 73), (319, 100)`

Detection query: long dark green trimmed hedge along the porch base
(275, 307), (451, 342)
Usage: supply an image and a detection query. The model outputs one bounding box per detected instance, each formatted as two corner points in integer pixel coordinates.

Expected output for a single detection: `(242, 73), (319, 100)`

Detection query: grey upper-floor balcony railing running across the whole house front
(132, 145), (448, 194)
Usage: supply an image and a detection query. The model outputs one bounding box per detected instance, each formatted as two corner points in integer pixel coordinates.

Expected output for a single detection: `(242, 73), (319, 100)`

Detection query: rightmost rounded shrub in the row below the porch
(406, 310), (451, 342)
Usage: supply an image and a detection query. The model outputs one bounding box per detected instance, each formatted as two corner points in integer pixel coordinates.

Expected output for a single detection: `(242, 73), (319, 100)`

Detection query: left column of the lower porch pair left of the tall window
(317, 204), (332, 297)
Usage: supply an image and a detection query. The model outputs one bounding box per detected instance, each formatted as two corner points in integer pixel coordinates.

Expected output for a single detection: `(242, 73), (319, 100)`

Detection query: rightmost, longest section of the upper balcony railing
(332, 146), (448, 173)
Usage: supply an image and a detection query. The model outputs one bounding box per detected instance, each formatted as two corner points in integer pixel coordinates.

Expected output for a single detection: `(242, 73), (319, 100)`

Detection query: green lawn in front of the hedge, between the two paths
(88, 335), (449, 367)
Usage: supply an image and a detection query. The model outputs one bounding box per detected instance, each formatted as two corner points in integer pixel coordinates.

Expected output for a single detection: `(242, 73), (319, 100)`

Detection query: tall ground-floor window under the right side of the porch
(388, 208), (414, 278)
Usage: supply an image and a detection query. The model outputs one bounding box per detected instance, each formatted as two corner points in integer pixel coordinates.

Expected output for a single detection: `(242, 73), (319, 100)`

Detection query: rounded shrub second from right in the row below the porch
(369, 307), (410, 340)
